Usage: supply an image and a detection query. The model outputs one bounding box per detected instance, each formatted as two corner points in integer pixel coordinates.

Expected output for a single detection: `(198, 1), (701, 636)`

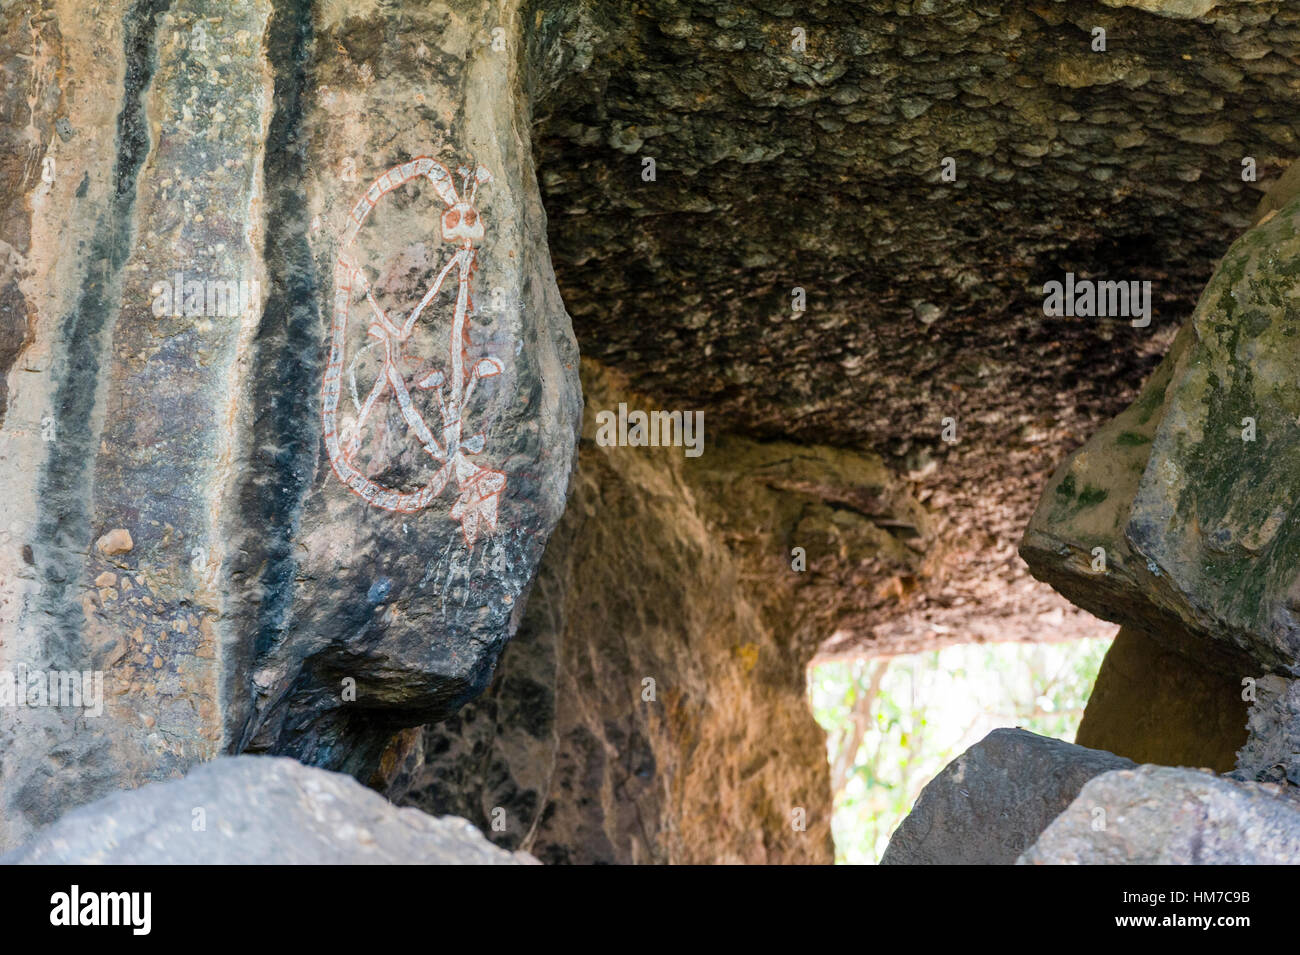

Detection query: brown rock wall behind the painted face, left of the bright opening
(373, 364), (956, 863)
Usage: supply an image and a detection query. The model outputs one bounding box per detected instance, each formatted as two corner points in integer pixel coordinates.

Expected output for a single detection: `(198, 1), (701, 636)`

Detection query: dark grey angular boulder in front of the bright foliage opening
(880, 729), (1135, 865)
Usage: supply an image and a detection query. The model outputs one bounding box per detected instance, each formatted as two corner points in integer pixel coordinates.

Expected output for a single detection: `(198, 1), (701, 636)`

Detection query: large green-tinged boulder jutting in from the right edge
(1021, 194), (1300, 678)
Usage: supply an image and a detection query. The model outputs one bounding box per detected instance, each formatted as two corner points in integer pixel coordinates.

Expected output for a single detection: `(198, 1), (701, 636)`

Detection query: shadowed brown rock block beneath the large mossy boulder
(1074, 626), (1251, 773)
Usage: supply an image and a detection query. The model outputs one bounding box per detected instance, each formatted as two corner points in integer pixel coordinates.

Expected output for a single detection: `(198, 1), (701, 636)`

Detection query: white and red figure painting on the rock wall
(321, 156), (506, 546)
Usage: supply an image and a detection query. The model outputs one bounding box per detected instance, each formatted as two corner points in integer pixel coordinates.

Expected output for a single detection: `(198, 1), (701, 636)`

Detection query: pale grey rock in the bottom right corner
(1019, 765), (1300, 865)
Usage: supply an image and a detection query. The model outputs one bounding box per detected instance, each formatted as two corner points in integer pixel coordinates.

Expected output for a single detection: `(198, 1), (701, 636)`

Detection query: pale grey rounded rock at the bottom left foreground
(0, 756), (536, 865)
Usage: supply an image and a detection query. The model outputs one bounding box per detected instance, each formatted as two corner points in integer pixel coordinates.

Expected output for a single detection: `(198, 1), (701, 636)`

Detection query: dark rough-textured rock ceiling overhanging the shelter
(520, 0), (1300, 648)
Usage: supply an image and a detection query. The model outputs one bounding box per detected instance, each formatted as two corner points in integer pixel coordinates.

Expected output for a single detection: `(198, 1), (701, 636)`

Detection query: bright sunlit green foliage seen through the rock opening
(809, 639), (1110, 864)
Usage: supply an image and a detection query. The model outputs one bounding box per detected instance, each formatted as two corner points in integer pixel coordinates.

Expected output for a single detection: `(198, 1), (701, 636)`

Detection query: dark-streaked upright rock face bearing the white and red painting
(0, 0), (581, 846)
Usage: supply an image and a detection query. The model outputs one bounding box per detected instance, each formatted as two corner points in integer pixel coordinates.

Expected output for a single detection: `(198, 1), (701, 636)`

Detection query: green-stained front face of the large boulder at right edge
(1126, 201), (1300, 665)
